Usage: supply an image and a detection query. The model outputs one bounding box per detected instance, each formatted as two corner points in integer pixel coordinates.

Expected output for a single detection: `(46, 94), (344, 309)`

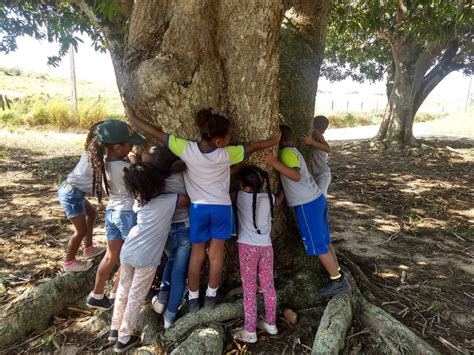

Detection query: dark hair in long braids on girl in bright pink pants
(239, 165), (273, 234)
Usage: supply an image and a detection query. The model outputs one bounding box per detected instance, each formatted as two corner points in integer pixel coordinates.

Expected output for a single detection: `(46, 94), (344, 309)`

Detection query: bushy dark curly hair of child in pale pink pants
(123, 164), (166, 207)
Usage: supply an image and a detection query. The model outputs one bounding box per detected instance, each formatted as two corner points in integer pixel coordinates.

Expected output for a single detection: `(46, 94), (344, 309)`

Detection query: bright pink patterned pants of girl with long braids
(239, 243), (277, 333)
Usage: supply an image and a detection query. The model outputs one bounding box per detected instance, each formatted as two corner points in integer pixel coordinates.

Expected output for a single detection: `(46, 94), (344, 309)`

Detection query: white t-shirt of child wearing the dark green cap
(105, 160), (133, 211)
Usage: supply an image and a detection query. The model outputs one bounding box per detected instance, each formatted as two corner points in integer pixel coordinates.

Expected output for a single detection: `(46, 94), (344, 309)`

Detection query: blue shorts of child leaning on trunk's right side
(294, 195), (331, 255)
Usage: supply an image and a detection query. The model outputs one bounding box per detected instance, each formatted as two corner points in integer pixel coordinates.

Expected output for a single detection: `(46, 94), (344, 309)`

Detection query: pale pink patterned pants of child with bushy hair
(110, 264), (156, 343)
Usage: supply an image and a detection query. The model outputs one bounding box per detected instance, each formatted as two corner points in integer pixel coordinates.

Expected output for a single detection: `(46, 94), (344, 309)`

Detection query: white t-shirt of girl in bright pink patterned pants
(237, 191), (275, 247)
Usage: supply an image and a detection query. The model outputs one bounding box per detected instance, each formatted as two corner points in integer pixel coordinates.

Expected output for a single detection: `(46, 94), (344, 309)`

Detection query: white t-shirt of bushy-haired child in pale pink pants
(120, 194), (178, 268)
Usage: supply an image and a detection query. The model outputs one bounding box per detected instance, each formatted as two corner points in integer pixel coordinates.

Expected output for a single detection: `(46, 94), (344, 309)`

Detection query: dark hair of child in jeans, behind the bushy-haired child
(142, 146), (186, 177)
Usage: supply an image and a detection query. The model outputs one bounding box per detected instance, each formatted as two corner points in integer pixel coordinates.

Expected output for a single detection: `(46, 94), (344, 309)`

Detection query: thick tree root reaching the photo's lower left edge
(0, 267), (97, 347)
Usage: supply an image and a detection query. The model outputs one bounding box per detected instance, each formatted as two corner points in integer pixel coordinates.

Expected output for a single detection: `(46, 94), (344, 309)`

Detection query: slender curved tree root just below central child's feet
(165, 300), (244, 343)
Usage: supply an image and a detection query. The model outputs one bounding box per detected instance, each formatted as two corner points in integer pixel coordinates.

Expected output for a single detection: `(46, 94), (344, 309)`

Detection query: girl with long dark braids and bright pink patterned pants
(234, 166), (278, 343)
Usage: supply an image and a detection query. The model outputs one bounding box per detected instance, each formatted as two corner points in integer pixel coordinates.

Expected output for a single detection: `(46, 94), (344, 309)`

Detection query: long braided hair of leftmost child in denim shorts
(86, 136), (109, 203)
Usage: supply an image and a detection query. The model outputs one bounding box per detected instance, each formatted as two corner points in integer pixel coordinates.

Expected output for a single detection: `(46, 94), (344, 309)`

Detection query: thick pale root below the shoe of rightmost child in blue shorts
(311, 293), (353, 355)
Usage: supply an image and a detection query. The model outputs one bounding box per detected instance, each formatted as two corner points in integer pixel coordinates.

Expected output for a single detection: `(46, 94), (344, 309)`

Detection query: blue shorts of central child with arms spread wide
(189, 203), (232, 243)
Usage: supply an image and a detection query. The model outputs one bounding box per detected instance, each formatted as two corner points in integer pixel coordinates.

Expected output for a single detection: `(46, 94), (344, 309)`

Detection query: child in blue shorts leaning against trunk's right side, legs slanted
(261, 125), (351, 297)
